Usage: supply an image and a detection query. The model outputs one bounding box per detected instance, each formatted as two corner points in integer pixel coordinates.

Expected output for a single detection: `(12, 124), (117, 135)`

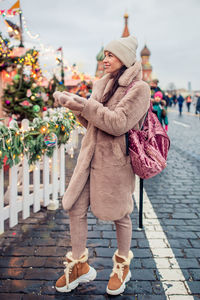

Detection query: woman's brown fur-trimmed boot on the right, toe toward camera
(106, 250), (133, 295)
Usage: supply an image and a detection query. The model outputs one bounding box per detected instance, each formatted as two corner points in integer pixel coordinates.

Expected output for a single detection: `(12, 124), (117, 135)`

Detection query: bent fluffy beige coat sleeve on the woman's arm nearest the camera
(81, 82), (150, 136)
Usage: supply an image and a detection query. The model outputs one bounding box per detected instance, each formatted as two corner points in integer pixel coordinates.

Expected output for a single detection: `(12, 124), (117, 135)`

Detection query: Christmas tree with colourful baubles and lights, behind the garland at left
(3, 49), (45, 121)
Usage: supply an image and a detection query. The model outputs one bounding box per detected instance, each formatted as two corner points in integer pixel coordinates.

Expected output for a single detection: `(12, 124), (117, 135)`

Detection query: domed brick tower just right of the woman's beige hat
(140, 45), (152, 83)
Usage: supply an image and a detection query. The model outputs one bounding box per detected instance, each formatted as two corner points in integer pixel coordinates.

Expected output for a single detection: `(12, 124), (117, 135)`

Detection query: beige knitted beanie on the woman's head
(104, 35), (138, 68)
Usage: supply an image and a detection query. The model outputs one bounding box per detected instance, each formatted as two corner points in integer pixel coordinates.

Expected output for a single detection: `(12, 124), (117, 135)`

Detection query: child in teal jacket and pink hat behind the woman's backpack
(152, 92), (168, 131)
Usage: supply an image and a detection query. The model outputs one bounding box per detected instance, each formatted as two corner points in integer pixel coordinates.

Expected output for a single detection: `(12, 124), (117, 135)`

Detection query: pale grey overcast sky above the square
(0, 0), (200, 90)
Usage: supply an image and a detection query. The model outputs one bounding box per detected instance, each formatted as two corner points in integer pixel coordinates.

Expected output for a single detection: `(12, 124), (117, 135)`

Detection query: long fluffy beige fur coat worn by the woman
(62, 62), (150, 220)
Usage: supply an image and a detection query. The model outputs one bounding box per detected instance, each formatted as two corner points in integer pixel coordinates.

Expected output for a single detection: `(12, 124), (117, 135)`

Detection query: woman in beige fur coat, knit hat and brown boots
(54, 36), (150, 295)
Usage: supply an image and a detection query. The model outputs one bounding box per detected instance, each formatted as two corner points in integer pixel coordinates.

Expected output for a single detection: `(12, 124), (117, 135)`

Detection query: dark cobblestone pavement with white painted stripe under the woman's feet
(0, 109), (200, 300)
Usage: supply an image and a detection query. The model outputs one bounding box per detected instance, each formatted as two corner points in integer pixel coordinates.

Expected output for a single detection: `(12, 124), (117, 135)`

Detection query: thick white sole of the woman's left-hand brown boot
(55, 267), (97, 293)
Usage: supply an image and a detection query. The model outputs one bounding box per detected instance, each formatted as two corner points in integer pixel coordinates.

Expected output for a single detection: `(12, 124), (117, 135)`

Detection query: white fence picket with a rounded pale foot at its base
(47, 146), (59, 210)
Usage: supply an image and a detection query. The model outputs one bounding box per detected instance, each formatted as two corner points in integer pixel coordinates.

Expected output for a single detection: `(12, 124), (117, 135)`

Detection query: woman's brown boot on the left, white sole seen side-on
(56, 249), (96, 293)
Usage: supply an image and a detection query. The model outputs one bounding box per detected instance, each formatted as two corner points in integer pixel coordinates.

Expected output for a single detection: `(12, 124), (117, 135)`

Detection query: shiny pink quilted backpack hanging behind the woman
(127, 82), (170, 179)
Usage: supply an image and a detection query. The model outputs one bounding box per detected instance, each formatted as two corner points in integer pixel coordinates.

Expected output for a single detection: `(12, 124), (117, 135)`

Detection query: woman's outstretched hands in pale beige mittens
(53, 92), (87, 111)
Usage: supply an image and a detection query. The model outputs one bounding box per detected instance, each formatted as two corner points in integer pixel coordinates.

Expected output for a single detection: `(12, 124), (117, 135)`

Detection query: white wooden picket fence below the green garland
(0, 121), (83, 234)
